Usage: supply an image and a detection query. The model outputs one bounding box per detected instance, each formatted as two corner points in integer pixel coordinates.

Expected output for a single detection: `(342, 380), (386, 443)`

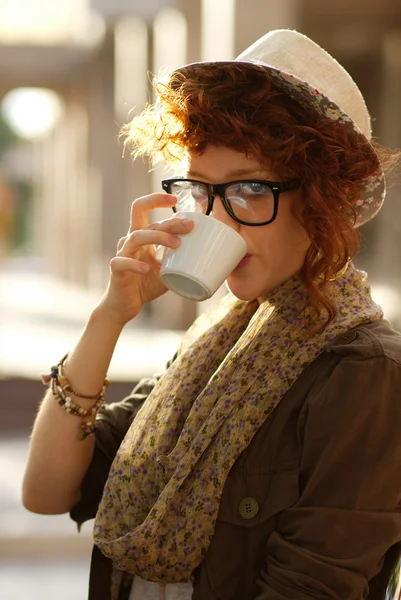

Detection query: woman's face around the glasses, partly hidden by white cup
(187, 146), (310, 301)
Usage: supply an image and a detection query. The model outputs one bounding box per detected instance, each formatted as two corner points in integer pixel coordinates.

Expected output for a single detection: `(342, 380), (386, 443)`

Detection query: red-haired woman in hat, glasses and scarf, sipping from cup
(24, 30), (401, 600)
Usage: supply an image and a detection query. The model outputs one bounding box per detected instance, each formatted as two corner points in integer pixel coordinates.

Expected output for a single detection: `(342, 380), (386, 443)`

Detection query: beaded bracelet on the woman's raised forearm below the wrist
(42, 353), (110, 440)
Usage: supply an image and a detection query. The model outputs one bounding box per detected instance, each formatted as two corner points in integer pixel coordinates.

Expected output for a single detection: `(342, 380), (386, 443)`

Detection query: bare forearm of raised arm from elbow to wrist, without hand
(23, 307), (123, 514)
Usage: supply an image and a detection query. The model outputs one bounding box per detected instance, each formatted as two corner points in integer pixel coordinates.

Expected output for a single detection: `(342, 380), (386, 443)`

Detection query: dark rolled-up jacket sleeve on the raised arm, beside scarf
(70, 375), (160, 527)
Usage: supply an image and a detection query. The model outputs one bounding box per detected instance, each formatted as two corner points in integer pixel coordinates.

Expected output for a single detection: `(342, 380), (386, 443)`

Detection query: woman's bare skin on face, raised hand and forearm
(23, 146), (310, 514)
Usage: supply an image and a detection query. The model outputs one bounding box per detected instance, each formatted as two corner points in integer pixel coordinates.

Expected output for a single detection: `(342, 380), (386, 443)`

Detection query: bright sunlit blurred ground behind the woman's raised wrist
(0, 259), (181, 381)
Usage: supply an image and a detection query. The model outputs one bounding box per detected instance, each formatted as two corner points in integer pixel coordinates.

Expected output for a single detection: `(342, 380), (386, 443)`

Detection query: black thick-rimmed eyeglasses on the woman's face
(162, 178), (298, 226)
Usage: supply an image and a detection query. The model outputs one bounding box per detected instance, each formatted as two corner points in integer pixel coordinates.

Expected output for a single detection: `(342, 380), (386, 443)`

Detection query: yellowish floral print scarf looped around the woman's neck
(94, 264), (382, 584)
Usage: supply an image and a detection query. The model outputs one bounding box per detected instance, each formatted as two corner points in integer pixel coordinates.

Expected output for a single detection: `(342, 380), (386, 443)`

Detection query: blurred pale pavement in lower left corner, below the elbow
(0, 435), (92, 600)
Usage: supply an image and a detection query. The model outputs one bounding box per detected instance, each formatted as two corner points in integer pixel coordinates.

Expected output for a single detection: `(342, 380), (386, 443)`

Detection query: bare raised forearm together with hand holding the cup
(23, 193), (188, 514)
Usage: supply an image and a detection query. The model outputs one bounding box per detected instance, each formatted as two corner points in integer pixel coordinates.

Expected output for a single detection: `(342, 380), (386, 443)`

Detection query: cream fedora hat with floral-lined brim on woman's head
(177, 29), (386, 227)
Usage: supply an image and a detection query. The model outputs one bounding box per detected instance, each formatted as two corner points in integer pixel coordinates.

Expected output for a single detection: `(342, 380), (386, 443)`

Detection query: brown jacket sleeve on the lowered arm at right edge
(255, 356), (401, 600)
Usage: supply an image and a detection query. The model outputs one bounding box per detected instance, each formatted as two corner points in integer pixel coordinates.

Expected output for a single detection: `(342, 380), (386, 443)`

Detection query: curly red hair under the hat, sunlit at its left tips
(122, 62), (392, 323)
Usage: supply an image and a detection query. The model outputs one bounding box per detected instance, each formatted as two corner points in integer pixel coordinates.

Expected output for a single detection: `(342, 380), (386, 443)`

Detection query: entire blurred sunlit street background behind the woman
(0, 0), (401, 600)
